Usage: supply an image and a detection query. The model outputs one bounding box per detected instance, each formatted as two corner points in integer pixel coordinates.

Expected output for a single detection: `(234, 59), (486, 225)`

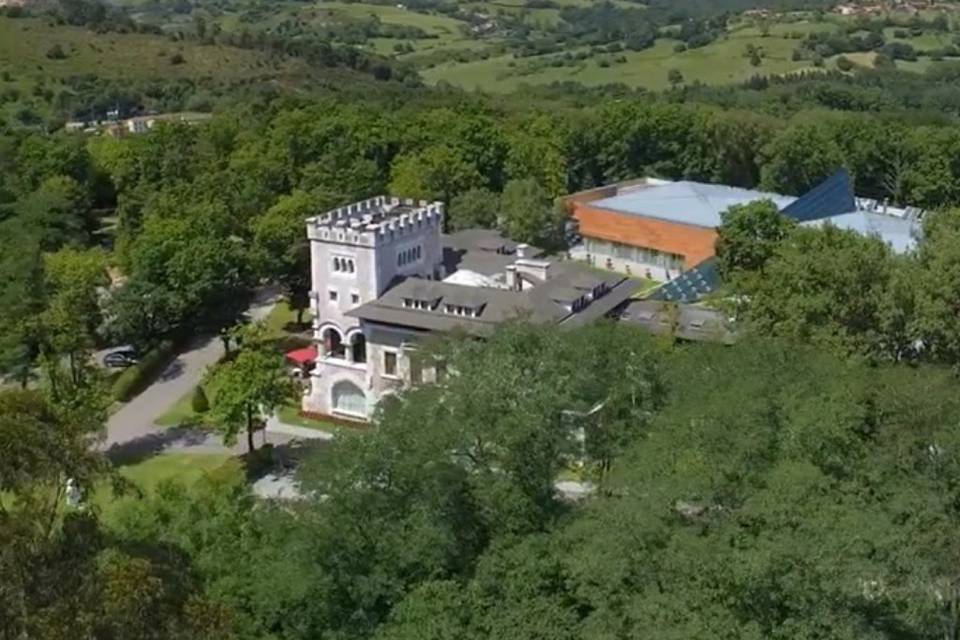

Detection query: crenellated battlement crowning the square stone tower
(307, 196), (443, 247)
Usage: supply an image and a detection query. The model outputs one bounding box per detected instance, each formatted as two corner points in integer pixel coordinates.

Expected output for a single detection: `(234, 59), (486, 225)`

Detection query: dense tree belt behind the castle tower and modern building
(9, 84), (960, 380)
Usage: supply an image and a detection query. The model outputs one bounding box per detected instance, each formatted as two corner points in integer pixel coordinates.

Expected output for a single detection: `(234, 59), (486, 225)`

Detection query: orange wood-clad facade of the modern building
(568, 201), (717, 269)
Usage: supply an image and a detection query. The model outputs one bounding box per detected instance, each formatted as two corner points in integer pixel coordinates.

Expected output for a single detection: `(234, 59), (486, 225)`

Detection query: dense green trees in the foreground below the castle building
(11, 326), (960, 640)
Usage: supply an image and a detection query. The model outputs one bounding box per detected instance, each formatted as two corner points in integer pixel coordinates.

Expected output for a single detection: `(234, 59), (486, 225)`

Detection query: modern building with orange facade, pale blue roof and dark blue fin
(566, 169), (922, 284)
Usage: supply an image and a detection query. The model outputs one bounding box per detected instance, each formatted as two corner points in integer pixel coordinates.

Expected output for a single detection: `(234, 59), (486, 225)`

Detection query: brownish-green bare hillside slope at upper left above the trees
(0, 17), (400, 126)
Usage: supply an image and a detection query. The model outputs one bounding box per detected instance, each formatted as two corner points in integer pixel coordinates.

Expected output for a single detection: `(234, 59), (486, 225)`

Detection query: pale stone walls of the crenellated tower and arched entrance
(303, 196), (444, 419)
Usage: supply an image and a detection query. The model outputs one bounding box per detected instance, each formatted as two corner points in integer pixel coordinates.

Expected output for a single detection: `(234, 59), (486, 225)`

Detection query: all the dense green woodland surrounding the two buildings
(9, 0), (960, 640)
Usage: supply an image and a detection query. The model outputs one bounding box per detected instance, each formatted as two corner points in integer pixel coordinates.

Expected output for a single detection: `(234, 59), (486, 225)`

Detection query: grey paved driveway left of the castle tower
(102, 294), (289, 459)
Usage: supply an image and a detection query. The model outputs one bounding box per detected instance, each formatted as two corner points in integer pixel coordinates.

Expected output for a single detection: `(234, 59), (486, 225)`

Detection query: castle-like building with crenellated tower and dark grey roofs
(302, 196), (639, 420)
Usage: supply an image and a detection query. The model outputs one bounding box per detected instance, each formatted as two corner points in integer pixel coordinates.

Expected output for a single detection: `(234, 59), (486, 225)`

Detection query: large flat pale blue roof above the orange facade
(592, 181), (796, 229)
